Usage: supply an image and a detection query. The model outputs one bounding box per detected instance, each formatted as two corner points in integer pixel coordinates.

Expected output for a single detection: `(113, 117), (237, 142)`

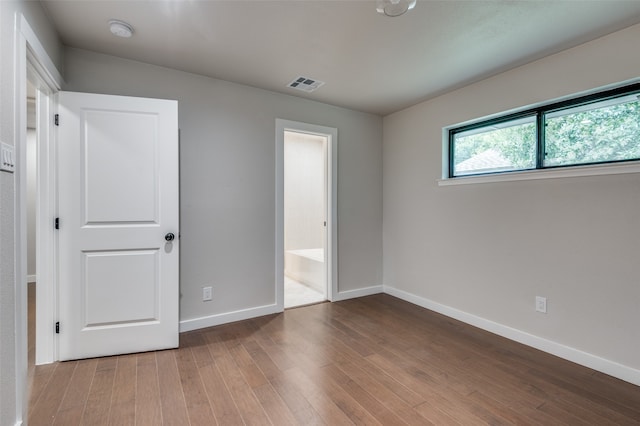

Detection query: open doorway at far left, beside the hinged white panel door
(25, 59), (57, 367)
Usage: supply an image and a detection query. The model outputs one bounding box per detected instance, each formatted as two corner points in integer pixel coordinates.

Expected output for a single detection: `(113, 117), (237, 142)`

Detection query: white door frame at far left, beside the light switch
(13, 13), (63, 420)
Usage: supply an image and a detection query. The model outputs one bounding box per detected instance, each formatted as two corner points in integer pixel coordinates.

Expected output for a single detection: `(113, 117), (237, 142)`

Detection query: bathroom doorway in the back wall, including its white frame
(276, 119), (337, 310)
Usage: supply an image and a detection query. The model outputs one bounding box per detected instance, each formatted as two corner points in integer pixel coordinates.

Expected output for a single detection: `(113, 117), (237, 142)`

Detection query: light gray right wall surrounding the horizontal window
(383, 21), (640, 380)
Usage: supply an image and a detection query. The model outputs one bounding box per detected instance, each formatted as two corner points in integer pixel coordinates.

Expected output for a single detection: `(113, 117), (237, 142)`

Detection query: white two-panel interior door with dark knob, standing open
(58, 92), (179, 360)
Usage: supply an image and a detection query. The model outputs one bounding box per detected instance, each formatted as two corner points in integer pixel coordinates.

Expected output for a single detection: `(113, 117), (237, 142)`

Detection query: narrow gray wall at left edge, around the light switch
(0, 1), (62, 425)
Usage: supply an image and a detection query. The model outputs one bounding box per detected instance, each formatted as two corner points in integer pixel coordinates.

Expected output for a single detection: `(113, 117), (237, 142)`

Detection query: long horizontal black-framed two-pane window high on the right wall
(449, 83), (640, 178)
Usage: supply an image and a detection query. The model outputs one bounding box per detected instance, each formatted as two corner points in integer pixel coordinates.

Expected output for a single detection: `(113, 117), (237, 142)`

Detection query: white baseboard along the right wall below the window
(384, 286), (640, 386)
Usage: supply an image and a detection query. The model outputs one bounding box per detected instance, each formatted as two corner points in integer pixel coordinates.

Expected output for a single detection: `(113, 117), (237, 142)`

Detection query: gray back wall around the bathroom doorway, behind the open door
(64, 49), (382, 320)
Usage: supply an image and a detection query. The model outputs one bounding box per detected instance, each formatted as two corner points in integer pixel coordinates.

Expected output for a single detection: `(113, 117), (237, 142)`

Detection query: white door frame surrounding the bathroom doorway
(275, 118), (338, 311)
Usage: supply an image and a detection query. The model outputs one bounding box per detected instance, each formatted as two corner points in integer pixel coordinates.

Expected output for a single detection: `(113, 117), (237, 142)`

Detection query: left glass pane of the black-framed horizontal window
(452, 116), (536, 176)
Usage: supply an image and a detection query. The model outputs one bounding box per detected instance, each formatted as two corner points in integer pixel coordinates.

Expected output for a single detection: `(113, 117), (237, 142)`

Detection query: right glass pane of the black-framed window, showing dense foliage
(543, 95), (640, 167)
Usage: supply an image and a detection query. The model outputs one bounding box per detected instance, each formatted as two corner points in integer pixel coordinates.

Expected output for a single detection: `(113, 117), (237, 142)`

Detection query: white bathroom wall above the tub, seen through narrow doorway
(284, 132), (326, 253)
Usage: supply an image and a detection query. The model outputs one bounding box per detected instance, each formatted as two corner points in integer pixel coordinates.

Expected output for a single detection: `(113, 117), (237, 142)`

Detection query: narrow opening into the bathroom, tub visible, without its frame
(284, 130), (328, 308)
